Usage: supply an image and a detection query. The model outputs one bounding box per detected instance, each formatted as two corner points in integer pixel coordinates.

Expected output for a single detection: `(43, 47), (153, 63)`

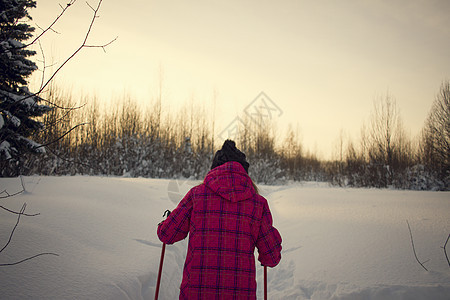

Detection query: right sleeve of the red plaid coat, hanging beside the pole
(256, 201), (281, 268)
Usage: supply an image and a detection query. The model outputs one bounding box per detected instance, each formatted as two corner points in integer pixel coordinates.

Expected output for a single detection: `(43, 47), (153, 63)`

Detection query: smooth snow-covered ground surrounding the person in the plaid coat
(0, 176), (450, 300)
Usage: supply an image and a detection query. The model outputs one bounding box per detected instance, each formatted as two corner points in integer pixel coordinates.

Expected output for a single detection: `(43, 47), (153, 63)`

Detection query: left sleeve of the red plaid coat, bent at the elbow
(157, 190), (193, 244)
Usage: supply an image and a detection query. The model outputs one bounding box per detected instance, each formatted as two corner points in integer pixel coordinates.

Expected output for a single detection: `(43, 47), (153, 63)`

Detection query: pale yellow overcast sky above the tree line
(31, 0), (450, 158)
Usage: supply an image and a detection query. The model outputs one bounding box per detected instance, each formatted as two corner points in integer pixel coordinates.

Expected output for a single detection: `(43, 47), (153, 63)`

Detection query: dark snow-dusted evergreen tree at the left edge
(0, 0), (51, 176)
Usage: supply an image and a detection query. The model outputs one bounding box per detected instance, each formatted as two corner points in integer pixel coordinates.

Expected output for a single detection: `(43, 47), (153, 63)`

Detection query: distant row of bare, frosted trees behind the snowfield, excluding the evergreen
(7, 81), (450, 190)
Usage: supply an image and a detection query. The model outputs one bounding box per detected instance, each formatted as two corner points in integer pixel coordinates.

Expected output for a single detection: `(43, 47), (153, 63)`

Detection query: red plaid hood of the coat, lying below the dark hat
(204, 161), (256, 202)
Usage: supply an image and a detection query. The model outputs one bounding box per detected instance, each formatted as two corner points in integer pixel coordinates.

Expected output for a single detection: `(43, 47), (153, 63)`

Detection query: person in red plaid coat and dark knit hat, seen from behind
(157, 140), (282, 300)
